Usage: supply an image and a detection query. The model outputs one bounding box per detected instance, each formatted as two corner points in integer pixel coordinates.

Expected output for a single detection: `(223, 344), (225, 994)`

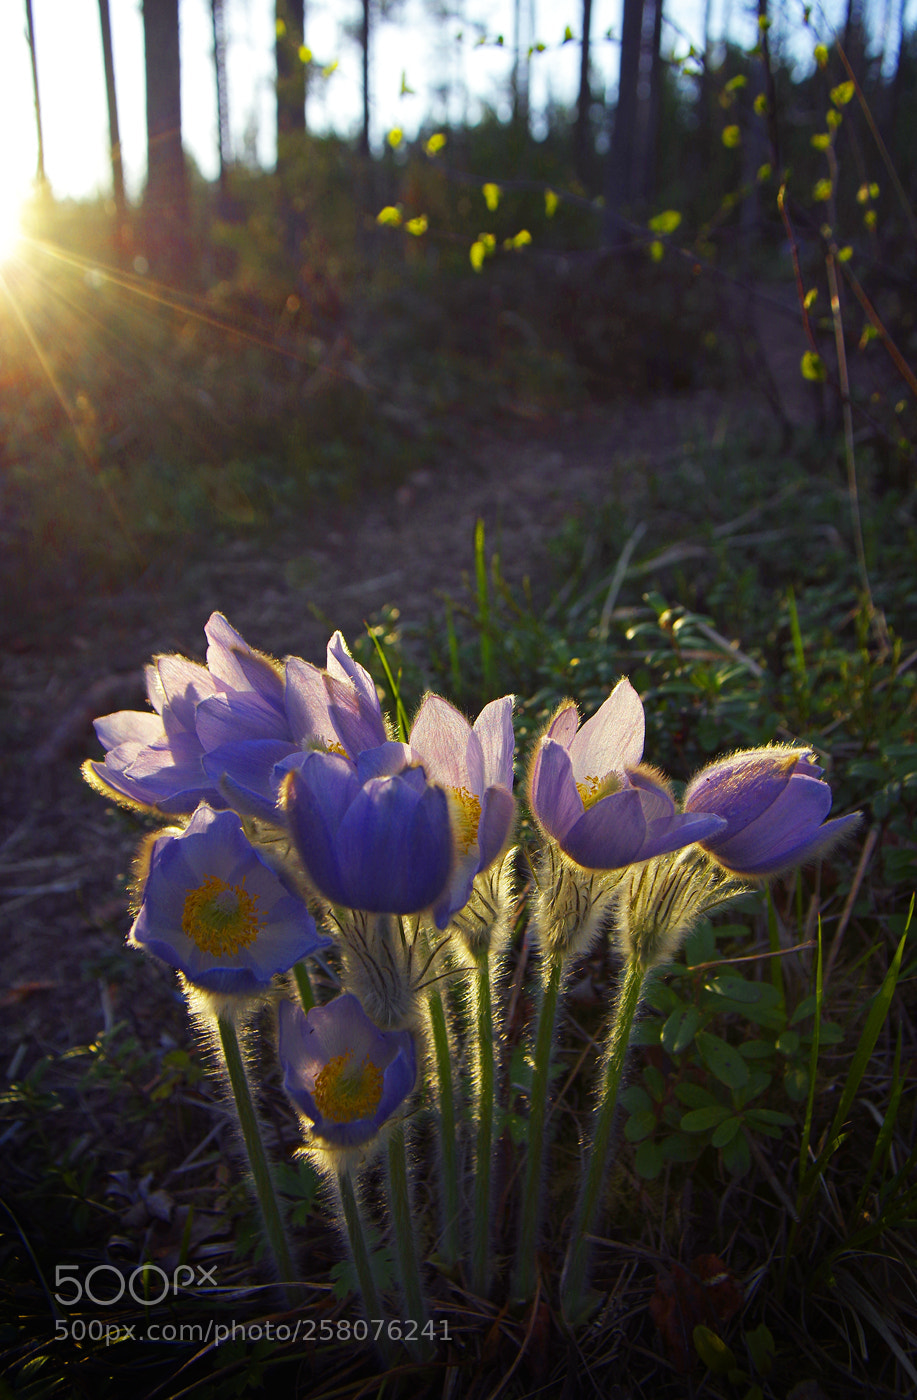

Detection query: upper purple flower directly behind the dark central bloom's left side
(202, 631), (389, 822)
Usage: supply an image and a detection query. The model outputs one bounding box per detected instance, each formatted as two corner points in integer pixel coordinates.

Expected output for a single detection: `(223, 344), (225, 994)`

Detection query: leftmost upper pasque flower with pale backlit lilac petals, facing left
(83, 613), (288, 815)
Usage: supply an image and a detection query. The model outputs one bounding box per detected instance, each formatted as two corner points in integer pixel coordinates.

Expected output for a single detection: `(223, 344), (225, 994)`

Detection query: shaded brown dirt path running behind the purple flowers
(0, 393), (749, 1074)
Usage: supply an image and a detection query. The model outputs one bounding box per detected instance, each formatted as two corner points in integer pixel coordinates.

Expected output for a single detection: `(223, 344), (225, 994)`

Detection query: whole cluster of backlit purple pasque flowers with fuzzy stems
(84, 613), (858, 1308)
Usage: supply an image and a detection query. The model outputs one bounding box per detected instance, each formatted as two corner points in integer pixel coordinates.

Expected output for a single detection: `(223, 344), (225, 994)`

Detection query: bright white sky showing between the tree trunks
(0, 0), (862, 208)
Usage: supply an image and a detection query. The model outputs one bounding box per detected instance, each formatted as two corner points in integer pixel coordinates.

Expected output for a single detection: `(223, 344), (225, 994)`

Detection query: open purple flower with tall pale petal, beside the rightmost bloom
(529, 679), (724, 869)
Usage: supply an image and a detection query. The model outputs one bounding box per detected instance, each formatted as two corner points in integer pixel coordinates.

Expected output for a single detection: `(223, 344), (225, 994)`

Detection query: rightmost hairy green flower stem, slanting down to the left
(560, 958), (650, 1323)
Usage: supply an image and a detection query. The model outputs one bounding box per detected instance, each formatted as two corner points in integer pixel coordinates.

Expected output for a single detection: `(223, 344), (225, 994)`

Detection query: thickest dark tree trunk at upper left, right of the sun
(143, 0), (190, 283)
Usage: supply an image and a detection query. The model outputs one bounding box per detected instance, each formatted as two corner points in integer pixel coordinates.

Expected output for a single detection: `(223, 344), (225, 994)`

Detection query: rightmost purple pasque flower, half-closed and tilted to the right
(685, 745), (861, 878)
